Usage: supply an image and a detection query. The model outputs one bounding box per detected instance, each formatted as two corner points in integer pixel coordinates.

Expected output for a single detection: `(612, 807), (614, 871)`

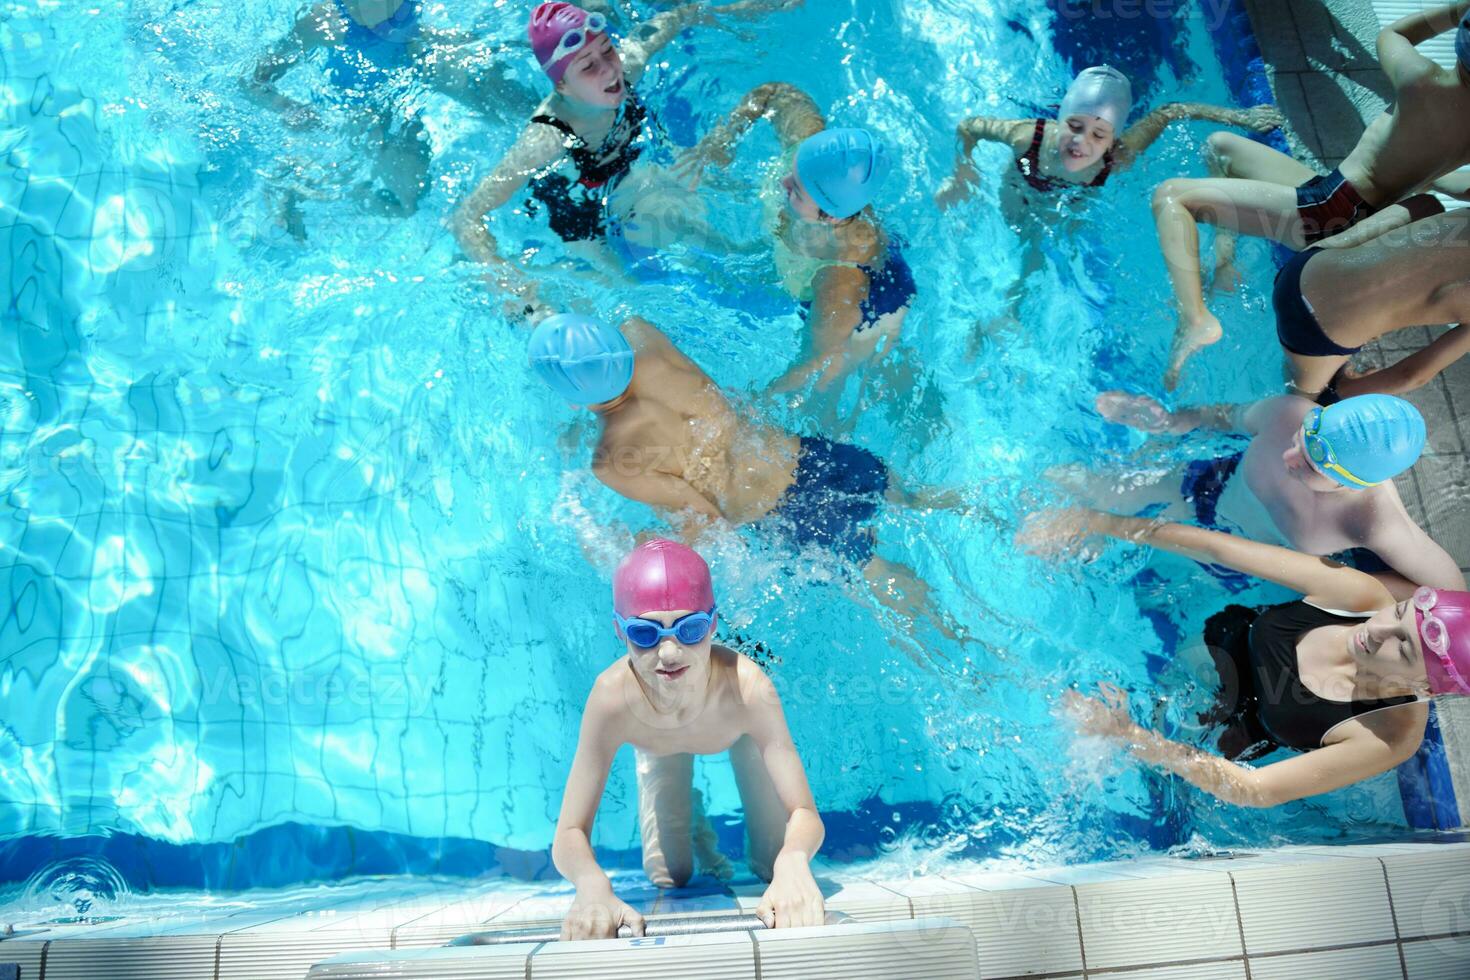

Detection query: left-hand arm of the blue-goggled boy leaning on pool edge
(551, 674), (644, 940)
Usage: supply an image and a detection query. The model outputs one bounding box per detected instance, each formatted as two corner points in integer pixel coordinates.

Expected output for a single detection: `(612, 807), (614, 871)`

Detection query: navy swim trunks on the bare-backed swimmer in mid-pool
(761, 436), (888, 566)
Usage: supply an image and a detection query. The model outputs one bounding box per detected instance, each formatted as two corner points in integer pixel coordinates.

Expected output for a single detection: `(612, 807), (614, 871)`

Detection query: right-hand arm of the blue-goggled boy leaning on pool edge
(741, 664), (826, 929)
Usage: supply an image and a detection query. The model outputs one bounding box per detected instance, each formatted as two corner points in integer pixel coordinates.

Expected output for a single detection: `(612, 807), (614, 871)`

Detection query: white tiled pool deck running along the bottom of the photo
(0, 842), (1470, 980)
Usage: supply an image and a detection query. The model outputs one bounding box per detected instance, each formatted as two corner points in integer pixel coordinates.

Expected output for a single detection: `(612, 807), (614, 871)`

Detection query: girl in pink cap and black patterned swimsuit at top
(453, 0), (800, 307)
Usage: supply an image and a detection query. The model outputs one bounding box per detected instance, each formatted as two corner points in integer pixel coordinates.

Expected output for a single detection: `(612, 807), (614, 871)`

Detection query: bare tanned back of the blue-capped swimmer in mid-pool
(595, 317), (800, 525)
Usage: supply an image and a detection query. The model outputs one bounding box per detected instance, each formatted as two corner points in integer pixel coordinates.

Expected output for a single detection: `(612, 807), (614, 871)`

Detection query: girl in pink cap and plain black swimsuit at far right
(1019, 510), (1470, 807)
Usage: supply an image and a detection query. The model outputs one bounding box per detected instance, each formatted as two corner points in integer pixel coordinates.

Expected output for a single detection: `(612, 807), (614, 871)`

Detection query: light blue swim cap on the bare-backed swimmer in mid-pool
(529, 313), (634, 406)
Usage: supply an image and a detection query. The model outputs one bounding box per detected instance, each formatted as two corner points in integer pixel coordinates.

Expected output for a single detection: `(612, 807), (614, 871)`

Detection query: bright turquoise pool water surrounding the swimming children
(0, 0), (1422, 905)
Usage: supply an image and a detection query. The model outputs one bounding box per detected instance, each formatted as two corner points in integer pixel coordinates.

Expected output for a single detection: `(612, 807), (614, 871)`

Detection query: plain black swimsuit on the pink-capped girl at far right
(1205, 599), (1419, 760)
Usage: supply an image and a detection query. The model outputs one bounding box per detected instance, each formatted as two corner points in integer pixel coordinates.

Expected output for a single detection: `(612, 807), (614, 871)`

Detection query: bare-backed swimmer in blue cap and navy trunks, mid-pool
(529, 314), (966, 652)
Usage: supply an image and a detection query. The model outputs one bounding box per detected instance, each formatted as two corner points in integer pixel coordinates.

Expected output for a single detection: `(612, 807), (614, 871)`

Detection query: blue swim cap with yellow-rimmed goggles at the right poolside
(1307, 395), (1426, 489)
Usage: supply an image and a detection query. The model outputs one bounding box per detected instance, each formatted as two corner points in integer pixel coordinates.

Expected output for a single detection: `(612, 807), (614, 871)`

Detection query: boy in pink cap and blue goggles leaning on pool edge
(551, 538), (825, 939)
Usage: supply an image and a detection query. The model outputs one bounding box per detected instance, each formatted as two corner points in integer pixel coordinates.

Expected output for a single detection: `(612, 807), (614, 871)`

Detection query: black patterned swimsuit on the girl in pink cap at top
(531, 82), (648, 241)
